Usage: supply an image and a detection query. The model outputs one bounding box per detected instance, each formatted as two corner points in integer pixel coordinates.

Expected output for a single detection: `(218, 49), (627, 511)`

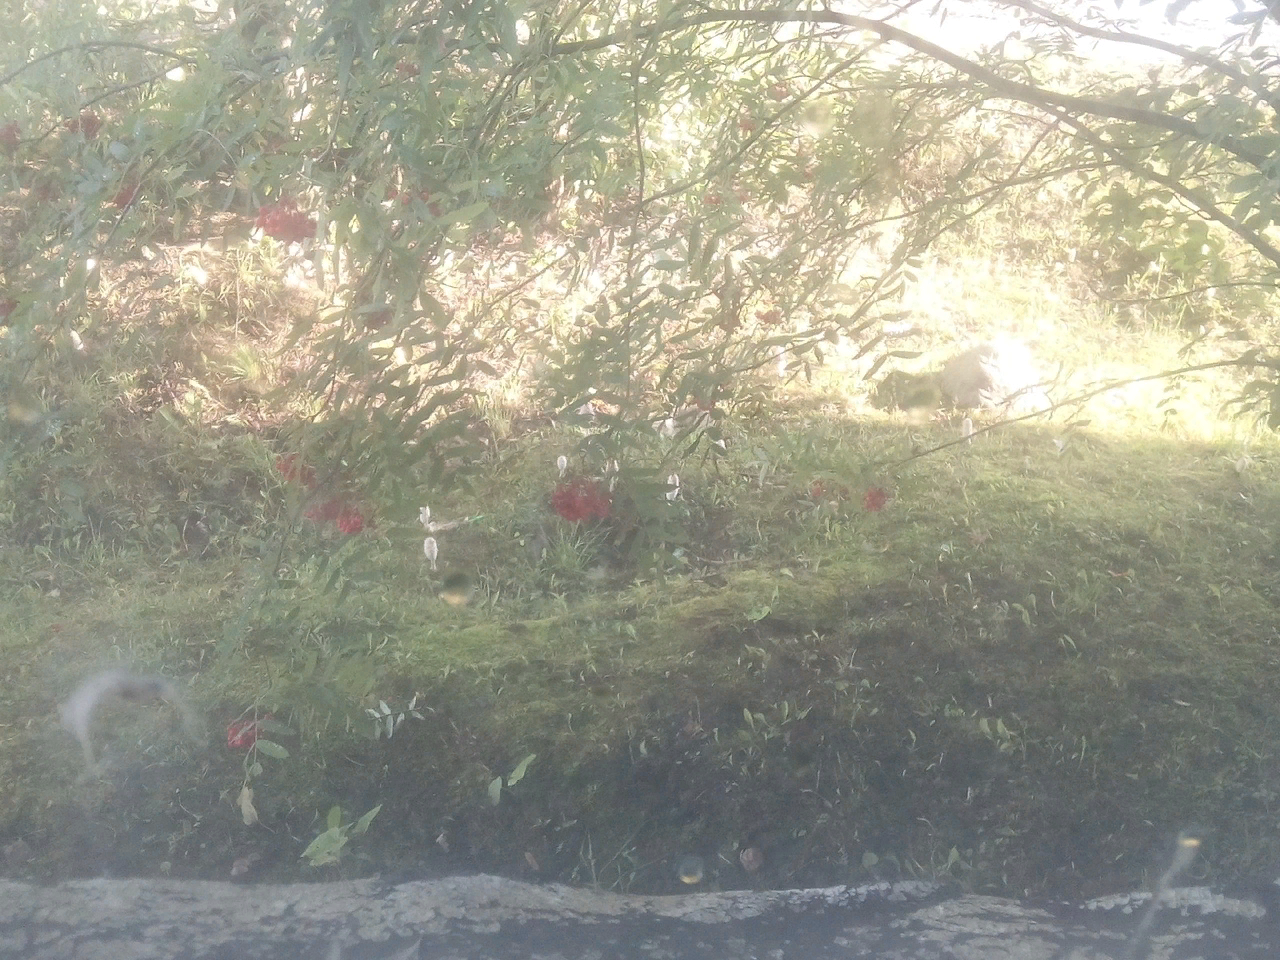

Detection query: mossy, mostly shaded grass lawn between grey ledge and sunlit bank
(0, 378), (1280, 895)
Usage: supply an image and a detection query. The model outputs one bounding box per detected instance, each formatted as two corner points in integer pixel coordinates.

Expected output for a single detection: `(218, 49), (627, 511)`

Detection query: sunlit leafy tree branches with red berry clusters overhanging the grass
(0, 0), (1280, 455)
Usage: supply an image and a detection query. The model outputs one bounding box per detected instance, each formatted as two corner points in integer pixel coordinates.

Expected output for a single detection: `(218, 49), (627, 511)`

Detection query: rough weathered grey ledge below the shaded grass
(0, 876), (1280, 960)
